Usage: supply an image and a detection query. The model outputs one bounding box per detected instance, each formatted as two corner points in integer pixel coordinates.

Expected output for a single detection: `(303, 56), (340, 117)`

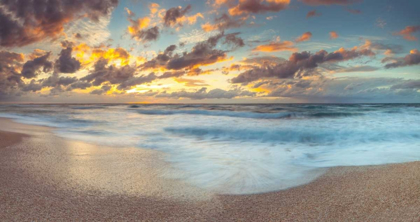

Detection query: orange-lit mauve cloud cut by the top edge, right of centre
(229, 0), (290, 16)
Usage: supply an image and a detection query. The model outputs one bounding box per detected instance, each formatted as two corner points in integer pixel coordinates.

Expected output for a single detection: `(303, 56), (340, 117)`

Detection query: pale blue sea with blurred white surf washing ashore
(0, 104), (420, 194)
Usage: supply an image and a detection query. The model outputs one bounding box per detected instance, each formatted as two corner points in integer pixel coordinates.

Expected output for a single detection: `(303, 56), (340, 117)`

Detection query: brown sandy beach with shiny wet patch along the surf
(0, 119), (420, 221)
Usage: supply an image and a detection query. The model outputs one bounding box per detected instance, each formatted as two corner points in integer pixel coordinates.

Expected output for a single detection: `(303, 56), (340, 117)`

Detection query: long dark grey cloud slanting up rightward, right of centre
(231, 49), (375, 84)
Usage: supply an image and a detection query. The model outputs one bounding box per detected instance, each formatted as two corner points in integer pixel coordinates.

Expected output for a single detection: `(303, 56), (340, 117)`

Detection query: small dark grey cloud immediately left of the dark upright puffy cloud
(21, 53), (53, 79)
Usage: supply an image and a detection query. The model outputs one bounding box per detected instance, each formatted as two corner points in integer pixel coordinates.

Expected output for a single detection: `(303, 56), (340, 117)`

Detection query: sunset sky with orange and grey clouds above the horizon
(0, 0), (420, 103)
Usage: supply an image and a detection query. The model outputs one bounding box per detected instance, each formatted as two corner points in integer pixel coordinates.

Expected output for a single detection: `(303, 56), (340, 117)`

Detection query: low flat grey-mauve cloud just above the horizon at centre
(156, 87), (256, 100)
